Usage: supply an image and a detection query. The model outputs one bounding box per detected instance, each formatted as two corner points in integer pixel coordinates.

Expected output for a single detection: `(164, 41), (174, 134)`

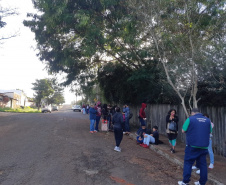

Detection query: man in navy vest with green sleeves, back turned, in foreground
(178, 108), (212, 185)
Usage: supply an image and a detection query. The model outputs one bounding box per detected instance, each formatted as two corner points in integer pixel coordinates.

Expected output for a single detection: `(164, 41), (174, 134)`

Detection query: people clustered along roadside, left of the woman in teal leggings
(86, 101), (159, 152)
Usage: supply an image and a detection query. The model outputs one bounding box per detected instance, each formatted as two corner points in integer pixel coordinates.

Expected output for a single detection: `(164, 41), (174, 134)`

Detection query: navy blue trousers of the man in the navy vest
(183, 146), (208, 185)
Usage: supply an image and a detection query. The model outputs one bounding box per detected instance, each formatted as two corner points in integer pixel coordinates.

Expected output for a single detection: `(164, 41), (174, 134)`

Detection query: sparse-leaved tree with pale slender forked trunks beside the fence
(129, 0), (226, 116)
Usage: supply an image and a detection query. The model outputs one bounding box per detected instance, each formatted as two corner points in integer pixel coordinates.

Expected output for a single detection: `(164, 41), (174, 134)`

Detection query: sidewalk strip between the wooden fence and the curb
(130, 133), (226, 185)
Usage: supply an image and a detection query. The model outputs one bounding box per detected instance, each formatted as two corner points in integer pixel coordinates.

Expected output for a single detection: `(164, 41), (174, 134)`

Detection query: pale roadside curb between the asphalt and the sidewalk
(129, 133), (224, 185)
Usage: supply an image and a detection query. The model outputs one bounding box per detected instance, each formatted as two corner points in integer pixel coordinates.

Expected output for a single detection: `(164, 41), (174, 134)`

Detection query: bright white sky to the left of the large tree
(0, 0), (76, 104)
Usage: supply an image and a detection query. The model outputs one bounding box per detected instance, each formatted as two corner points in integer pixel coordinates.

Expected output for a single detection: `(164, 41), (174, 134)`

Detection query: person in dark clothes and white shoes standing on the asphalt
(112, 107), (123, 152)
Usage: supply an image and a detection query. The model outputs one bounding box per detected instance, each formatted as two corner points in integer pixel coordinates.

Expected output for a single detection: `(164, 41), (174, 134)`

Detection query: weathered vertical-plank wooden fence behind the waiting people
(130, 104), (226, 157)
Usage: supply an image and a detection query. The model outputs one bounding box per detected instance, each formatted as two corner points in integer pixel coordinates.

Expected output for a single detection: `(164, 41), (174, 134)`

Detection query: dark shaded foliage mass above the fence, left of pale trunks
(98, 61), (178, 104)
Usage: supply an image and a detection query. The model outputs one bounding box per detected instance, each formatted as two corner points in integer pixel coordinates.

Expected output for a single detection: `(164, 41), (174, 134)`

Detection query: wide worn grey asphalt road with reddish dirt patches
(0, 107), (182, 185)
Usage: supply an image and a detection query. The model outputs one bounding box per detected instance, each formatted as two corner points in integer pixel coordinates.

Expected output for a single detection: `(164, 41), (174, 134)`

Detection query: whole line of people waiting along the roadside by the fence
(85, 102), (214, 185)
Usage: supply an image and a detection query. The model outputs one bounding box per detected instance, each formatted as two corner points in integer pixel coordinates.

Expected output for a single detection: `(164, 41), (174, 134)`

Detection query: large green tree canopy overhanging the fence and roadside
(24, 0), (226, 109)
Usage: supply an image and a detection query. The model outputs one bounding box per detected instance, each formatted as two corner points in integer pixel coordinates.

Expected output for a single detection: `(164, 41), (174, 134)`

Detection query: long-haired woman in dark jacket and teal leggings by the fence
(166, 109), (178, 153)
